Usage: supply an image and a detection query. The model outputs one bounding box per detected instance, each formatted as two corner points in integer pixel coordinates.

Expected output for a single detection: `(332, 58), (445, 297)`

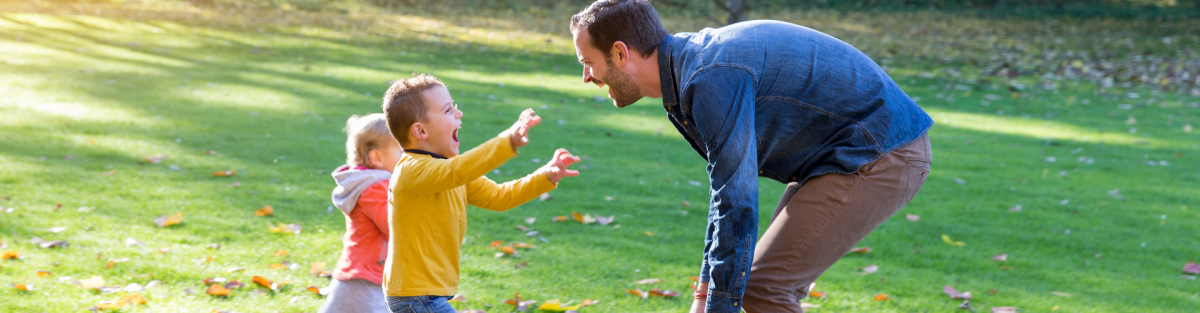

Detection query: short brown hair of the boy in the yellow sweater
(383, 74), (445, 146)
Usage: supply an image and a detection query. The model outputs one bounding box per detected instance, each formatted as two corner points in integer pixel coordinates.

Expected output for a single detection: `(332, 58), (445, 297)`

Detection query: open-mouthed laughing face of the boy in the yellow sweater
(421, 85), (462, 157)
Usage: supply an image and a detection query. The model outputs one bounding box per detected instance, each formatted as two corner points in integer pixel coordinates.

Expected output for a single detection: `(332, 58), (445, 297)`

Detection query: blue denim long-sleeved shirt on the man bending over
(658, 20), (934, 313)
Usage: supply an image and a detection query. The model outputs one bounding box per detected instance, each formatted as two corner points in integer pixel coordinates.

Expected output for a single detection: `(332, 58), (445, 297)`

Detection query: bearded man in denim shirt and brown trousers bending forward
(571, 0), (932, 312)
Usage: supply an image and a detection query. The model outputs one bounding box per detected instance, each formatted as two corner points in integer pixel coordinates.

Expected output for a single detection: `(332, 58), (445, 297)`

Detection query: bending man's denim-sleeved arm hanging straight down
(686, 67), (758, 313)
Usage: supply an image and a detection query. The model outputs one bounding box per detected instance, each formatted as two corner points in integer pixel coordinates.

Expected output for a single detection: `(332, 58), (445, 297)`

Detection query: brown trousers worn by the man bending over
(743, 134), (932, 313)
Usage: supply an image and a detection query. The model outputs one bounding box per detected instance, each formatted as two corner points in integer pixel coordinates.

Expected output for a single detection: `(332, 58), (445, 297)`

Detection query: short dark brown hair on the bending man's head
(571, 0), (671, 58)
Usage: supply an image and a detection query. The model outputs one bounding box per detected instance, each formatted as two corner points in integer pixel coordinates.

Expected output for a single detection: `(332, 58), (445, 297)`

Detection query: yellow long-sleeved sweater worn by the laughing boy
(383, 133), (556, 296)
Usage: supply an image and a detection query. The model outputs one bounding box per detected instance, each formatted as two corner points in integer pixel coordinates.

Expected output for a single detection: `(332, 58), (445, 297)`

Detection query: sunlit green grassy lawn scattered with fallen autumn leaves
(0, 4), (1200, 312)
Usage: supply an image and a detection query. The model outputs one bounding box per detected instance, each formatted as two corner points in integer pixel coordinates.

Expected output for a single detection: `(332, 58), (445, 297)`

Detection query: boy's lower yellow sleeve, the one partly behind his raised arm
(467, 170), (558, 211)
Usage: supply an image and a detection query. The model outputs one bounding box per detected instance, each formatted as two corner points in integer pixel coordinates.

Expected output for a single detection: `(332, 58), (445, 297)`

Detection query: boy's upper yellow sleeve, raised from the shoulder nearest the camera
(395, 137), (516, 194)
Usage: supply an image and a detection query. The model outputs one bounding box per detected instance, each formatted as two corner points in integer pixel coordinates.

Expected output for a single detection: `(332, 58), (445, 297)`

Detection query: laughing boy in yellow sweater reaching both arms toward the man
(383, 74), (578, 313)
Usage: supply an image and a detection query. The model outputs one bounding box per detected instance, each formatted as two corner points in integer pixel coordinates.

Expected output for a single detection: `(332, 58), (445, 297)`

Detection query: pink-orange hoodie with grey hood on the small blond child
(332, 165), (391, 284)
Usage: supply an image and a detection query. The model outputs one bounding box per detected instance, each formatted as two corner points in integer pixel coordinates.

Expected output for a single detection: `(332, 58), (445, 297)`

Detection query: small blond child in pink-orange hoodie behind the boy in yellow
(318, 113), (404, 313)
